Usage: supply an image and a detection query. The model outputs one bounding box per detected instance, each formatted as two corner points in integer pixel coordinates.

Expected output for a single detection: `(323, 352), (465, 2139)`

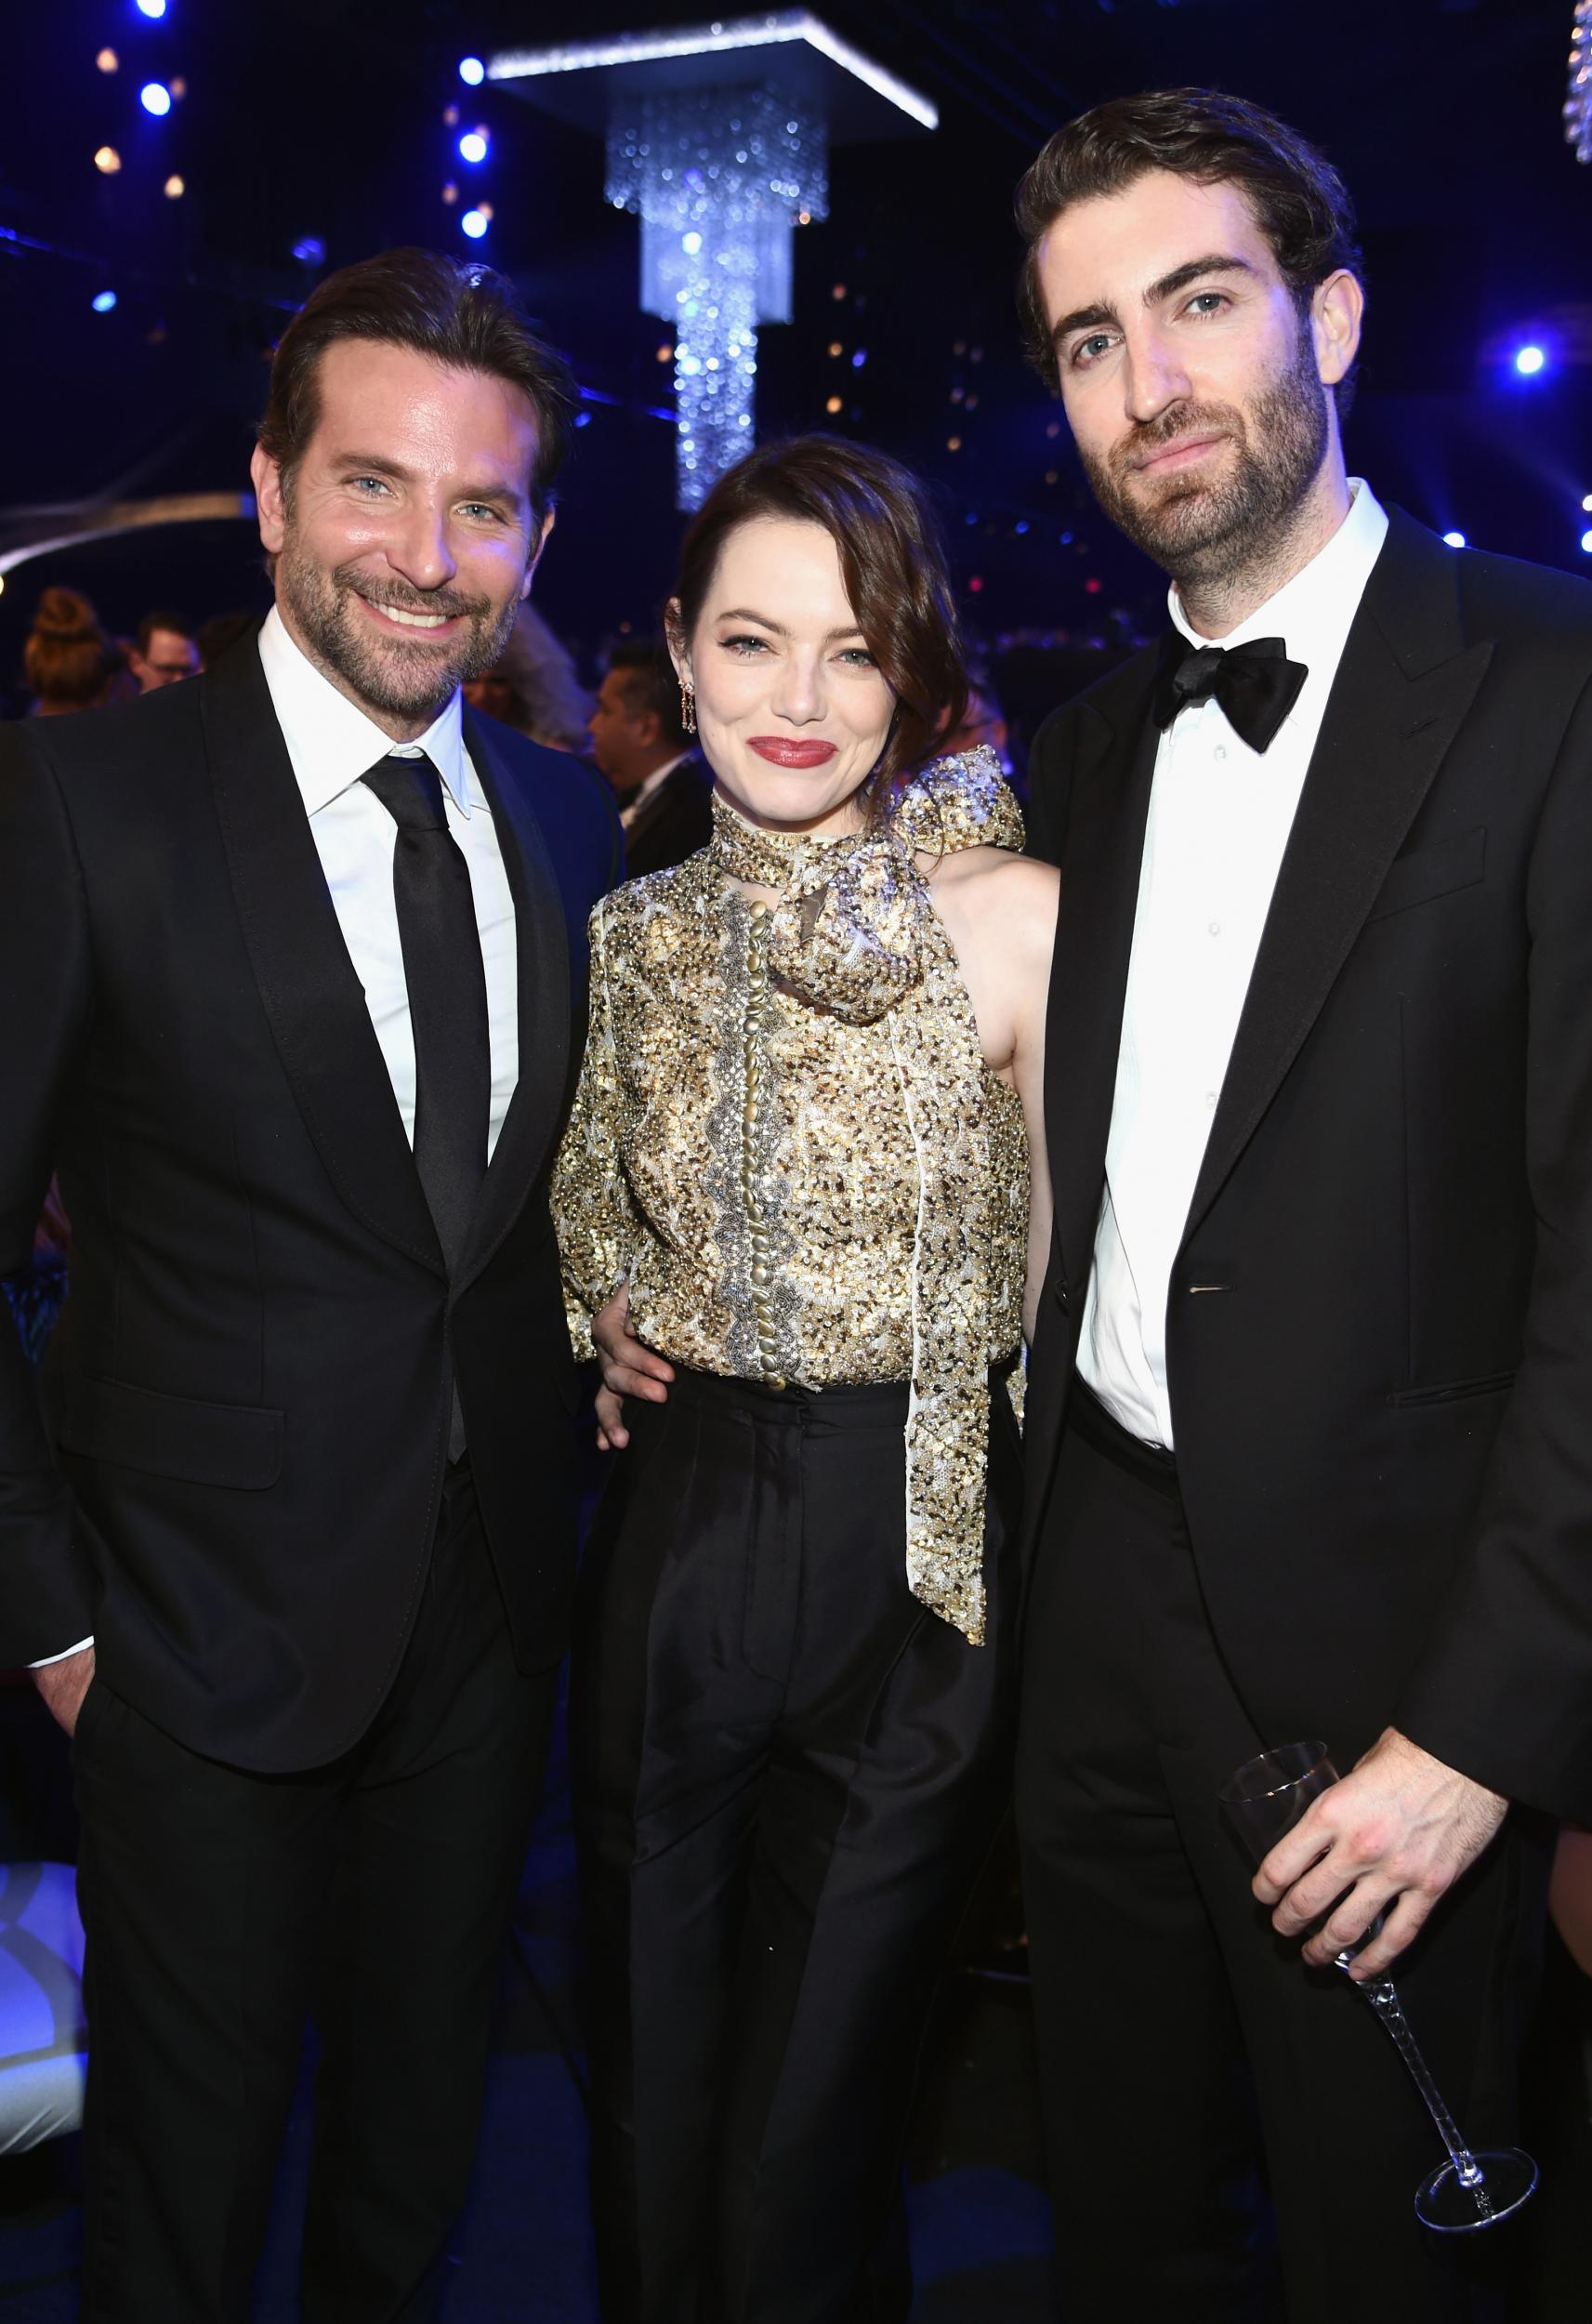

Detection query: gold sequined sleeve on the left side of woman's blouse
(551, 905), (641, 1360)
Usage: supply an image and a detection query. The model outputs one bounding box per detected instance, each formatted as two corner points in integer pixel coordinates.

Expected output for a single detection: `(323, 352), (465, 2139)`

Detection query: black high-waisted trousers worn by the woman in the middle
(572, 1374), (1020, 2324)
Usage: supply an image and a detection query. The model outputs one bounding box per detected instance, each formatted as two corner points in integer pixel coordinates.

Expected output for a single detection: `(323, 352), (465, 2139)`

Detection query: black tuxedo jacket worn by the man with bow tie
(1030, 511), (1592, 1820)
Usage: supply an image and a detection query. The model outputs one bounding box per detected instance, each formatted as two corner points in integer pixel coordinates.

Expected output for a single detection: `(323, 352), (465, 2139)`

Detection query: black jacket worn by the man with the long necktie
(0, 640), (621, 1771)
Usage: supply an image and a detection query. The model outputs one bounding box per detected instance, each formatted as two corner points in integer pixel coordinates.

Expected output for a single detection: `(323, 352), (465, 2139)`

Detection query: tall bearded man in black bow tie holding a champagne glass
(1018, 91), (1592, 2324)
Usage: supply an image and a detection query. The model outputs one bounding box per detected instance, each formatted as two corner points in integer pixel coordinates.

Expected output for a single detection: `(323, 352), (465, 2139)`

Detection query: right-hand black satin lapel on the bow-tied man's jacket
(1185, 511), (1492, 1232)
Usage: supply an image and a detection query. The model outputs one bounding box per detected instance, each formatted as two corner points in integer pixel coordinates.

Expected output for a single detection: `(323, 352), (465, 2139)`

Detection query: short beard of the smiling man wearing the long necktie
(277, 525), (520, 719)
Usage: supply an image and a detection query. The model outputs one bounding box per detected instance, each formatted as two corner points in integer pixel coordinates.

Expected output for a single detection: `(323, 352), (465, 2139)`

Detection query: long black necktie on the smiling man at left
(365, 753), (493, 1459)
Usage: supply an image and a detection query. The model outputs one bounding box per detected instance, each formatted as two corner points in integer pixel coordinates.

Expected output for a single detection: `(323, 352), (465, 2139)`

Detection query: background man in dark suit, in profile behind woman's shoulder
(588, 637), (714, 878)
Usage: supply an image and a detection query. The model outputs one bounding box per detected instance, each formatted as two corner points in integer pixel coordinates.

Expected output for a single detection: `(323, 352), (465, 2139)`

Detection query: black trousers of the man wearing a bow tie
(1018, 1390), (1546, 2324)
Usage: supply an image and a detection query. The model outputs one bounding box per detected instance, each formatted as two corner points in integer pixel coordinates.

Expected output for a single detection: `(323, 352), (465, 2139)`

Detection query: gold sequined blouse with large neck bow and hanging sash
(553, 748), (1027, 1641)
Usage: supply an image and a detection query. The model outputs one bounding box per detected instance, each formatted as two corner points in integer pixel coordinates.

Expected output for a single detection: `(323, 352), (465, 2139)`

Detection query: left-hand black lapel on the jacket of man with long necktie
(200, 654), (444, 1274)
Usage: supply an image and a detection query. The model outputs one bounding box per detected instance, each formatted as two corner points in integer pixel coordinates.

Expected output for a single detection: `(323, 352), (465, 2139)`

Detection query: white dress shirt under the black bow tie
(1078, 479), (1388, 1446)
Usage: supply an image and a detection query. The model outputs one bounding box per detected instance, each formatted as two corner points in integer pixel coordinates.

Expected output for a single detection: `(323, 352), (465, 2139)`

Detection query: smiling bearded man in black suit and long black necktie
(0, 251), (621, 2324)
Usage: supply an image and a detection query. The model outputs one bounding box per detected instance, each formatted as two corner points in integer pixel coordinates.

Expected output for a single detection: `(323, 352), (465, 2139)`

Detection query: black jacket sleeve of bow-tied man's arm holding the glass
(1394, 665), (1592, 1822)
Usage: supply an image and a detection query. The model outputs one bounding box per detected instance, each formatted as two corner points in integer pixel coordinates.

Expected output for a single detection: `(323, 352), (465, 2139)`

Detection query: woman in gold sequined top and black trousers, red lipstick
(553, 437), (1058, 2324)
